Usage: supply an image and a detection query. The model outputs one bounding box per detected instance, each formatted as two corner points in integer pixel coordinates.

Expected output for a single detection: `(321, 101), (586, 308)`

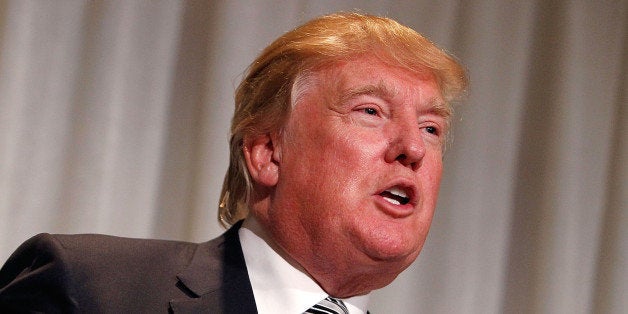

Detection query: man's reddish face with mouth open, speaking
(265, 57), (447, 294)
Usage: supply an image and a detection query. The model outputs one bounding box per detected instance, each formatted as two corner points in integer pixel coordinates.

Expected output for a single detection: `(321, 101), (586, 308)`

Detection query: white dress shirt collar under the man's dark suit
(239, 217), (368, 314)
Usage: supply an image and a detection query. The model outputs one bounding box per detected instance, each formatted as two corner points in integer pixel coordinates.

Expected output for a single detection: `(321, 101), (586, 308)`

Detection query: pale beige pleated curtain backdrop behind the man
(0, 0), (628, 314)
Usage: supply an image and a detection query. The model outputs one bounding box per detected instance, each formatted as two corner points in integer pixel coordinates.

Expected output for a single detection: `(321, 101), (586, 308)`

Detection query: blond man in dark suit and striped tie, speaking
(0, 14), (466, 314)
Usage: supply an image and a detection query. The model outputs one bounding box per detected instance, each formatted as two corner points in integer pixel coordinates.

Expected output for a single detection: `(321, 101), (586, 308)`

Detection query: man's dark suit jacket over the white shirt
(0, 223), (257, 314)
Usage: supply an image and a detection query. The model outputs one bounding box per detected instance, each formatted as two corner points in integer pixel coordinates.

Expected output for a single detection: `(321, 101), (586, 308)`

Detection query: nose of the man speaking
(385, 122), (425, 171)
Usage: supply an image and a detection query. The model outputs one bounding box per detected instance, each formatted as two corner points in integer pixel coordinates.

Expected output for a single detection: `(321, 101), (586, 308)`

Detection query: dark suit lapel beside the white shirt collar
(170, 222), (257, 313)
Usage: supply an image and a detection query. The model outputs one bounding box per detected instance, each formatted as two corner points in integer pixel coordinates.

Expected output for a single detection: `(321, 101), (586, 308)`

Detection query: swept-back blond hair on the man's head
(218, 13), (467, 226)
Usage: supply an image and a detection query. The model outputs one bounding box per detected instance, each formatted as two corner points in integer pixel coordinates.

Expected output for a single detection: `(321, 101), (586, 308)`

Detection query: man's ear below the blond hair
(244, 134), (281, 187)
